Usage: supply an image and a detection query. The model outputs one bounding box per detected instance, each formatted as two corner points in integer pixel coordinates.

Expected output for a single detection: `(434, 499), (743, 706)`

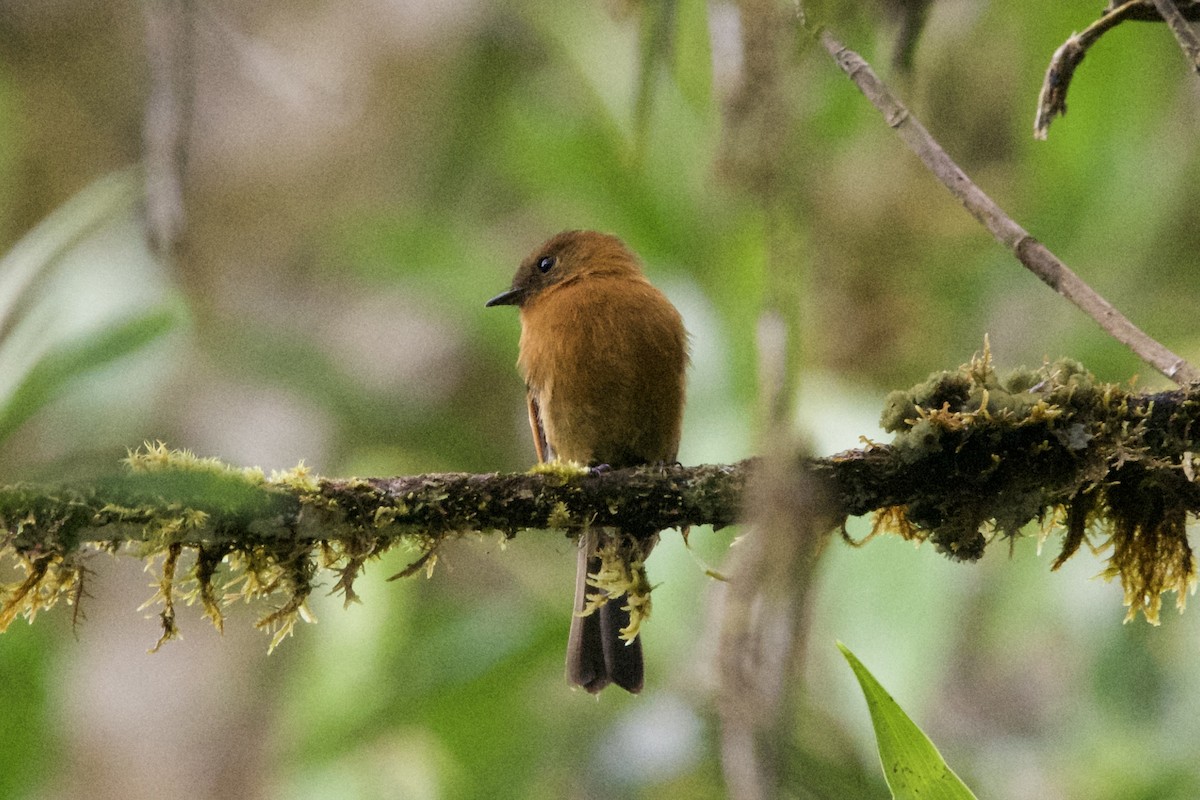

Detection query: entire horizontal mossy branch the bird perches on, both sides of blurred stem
(7, 351), (1200, 646)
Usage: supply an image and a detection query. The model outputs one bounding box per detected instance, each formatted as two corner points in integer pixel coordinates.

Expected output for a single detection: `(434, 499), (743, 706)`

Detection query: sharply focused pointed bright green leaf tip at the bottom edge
(838, 642), (976, 800)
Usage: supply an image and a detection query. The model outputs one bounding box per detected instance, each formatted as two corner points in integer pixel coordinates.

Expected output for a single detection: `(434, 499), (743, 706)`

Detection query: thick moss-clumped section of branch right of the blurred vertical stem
(817, 351), (1200, 624)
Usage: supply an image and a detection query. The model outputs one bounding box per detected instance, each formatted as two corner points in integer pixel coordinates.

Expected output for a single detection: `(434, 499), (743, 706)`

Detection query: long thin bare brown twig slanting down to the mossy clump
(820, 30), (1200, 385)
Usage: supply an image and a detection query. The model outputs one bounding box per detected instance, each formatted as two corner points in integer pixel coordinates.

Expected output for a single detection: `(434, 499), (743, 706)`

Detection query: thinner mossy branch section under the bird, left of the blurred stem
(0, 444), (744, 649)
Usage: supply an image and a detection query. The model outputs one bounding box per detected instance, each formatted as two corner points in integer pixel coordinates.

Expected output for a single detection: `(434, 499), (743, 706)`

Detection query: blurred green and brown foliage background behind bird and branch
(0, 0), (1200, 800)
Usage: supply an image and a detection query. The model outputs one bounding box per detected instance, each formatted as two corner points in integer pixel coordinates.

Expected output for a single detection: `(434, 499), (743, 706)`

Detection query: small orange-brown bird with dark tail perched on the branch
(485, 230), (689, 694)
